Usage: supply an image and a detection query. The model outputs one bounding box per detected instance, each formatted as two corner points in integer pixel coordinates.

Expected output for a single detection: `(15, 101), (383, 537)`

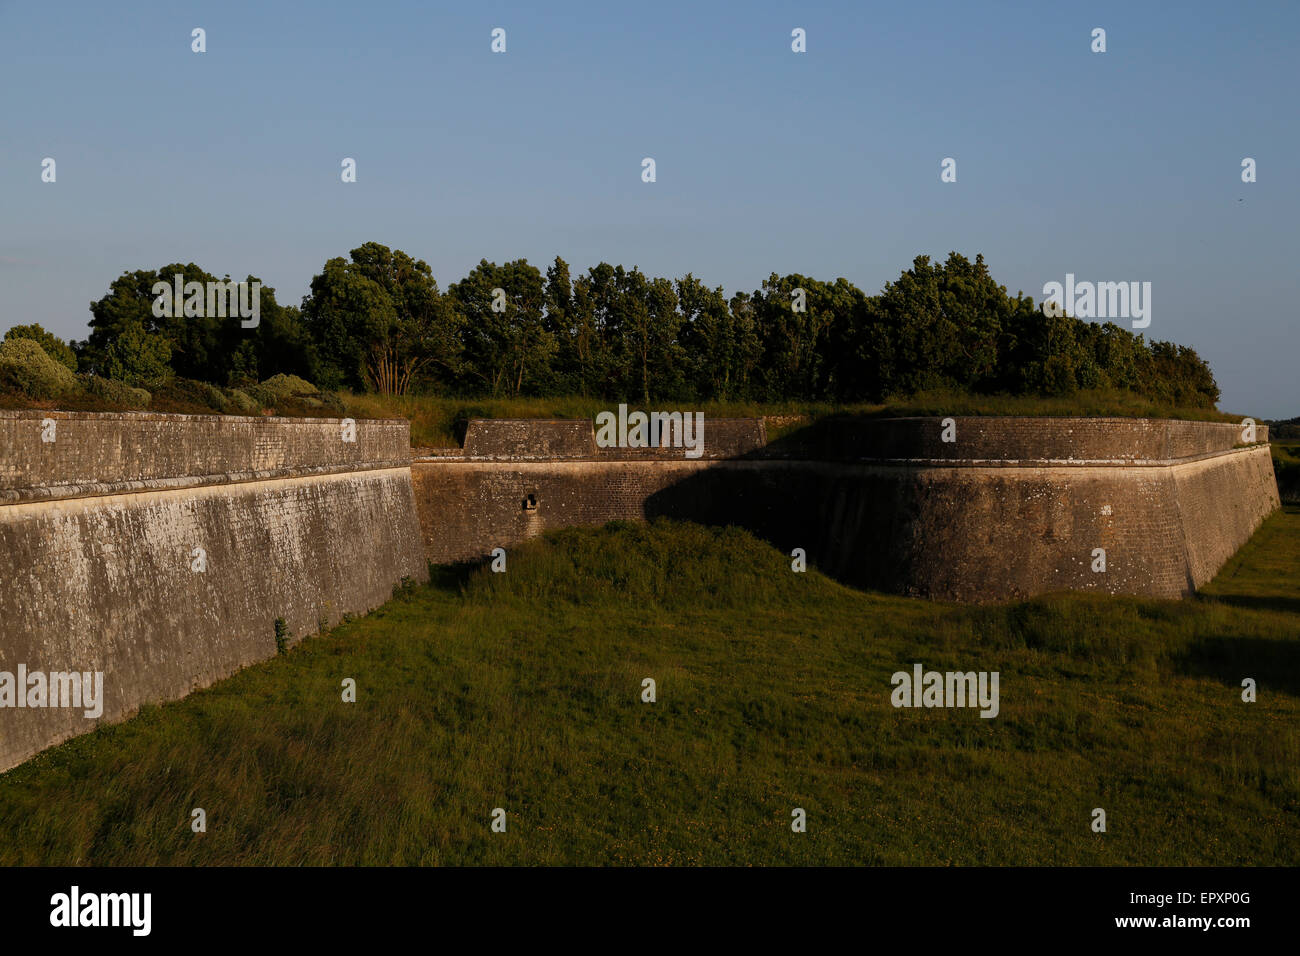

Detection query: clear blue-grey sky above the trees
(0, 0), (1300, 418)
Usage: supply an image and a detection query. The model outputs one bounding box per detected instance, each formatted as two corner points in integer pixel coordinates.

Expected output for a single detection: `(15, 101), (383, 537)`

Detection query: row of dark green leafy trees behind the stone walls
(22, 242), (1219, 407)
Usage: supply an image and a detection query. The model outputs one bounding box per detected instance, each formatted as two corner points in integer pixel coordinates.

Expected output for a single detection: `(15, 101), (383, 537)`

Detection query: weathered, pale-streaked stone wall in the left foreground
(0, 412), (428, 770)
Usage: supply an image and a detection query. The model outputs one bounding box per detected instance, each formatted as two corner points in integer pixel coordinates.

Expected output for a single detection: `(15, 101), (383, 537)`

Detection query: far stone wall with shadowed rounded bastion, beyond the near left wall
(412, 419), (1278, 601)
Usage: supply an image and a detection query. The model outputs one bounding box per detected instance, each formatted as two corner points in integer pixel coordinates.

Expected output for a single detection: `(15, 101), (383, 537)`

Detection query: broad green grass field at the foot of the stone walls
(0, 507), (1300, 865)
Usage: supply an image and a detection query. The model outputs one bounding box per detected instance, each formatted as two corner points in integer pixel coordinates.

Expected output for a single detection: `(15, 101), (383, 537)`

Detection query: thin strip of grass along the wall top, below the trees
(343, 392), (1244, 447)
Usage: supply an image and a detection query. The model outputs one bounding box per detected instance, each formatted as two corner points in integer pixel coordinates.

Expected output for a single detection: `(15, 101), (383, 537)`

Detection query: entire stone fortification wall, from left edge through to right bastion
(0, 411), (1278, 770)
